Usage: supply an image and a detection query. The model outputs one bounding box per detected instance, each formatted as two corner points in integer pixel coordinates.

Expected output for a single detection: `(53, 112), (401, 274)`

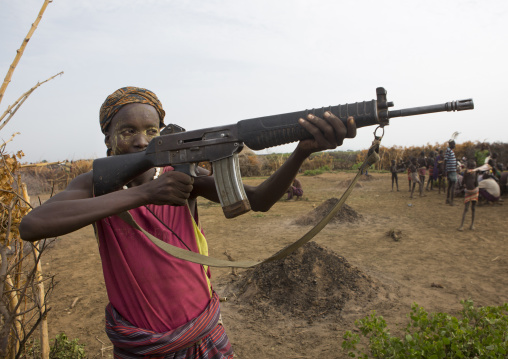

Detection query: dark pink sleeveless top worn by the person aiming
(96, 200), (211, 333)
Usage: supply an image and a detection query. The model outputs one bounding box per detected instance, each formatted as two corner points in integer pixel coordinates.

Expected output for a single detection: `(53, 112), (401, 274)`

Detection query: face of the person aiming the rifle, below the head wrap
(105, 103), (160, 155)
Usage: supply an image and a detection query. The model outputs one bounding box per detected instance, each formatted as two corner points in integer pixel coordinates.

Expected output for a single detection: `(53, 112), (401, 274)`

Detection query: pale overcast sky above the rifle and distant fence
(0, 0), (508, 162)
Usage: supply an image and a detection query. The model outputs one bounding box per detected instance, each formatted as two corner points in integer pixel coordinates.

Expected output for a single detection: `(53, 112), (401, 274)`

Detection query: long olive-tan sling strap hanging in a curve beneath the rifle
(118, 137), (381, 268)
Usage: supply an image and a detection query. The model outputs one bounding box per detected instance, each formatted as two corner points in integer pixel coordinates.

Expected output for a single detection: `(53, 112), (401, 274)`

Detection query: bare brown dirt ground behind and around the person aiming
(32, 173), (508, 359)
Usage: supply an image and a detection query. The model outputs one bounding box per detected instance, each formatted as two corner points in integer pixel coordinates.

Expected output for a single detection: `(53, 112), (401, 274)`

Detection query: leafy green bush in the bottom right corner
(342, 300), (508, 359)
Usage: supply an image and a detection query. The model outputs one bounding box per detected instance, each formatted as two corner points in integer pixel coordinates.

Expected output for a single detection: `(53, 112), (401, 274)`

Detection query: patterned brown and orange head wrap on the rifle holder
(99, 87), (166, 133)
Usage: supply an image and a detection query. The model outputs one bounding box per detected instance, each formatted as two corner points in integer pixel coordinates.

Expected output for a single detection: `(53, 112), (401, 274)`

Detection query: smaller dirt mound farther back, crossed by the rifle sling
(293, 198), (363, 226)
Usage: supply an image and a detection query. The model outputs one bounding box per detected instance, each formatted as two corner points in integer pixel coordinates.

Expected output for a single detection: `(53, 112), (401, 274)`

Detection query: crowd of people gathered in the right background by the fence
(390, 140), (508, 230)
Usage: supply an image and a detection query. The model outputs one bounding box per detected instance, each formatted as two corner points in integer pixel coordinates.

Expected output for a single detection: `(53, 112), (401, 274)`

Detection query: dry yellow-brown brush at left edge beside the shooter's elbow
(0, 146), (53, 358)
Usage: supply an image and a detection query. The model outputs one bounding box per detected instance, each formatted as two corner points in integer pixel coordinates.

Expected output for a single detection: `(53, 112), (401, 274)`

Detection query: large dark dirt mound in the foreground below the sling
(222, 242), (377, 320)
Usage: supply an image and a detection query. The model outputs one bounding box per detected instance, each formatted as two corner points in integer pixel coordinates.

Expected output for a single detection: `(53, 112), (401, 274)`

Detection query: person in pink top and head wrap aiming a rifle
(20, 87), (356, 358)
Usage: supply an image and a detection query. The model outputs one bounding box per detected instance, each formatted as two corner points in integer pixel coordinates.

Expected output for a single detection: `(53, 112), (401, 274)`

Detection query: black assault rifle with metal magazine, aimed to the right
(93, 87), (474, 218)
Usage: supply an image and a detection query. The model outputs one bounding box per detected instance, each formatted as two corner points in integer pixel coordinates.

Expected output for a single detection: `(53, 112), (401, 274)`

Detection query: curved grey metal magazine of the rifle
(212, 153), (250, 218)
